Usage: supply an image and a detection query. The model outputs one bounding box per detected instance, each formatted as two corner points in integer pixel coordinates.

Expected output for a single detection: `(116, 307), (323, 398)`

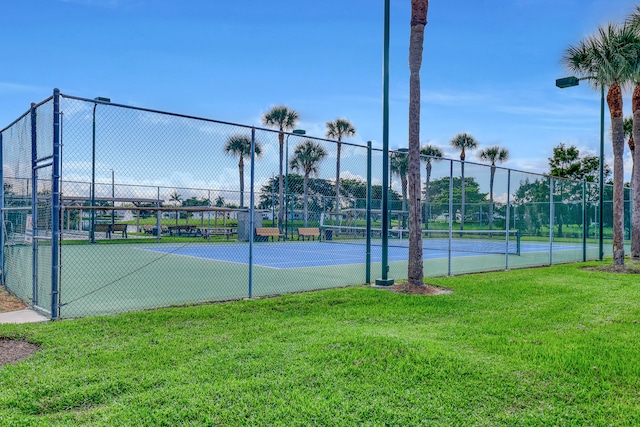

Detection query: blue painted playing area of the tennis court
(143, 242), (581, 269)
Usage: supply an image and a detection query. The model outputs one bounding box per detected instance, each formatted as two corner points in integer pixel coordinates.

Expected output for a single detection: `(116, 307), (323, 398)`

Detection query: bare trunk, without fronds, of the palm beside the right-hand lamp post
(607, 83), (624, 265)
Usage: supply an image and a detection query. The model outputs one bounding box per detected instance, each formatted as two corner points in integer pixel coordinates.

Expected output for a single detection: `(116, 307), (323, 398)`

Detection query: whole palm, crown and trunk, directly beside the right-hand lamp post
(562, 23), (638, 265)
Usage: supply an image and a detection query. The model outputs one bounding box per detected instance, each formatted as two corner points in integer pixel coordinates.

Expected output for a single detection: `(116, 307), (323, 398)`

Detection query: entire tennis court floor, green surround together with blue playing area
(6, 241), (597, 318)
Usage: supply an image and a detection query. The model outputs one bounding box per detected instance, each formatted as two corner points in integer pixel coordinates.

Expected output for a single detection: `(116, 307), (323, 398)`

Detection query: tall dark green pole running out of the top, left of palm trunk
(376, 0), (393, 286)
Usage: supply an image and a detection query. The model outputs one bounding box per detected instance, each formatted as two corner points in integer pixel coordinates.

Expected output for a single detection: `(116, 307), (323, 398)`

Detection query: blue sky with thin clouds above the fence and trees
(0, 0), (636, 176)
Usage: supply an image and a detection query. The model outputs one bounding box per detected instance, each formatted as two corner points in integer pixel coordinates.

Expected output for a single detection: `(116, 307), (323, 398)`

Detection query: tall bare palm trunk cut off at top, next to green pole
(407, 0), (429, 286)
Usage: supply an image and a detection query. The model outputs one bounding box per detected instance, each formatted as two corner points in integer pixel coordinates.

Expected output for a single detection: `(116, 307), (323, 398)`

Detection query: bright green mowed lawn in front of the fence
(0, 263), (640, 426)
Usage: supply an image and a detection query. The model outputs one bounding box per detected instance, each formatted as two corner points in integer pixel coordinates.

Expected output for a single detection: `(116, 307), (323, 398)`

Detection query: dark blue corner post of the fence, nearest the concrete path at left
(51, 89), (60, 320)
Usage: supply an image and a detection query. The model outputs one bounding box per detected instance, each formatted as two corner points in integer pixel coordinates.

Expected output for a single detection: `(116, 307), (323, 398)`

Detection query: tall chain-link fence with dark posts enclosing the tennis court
(0, 92), (629, 318)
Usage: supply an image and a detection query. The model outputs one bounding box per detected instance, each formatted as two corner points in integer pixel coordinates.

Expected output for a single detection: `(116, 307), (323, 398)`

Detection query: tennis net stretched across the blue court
(322, 226), (520, 255)
